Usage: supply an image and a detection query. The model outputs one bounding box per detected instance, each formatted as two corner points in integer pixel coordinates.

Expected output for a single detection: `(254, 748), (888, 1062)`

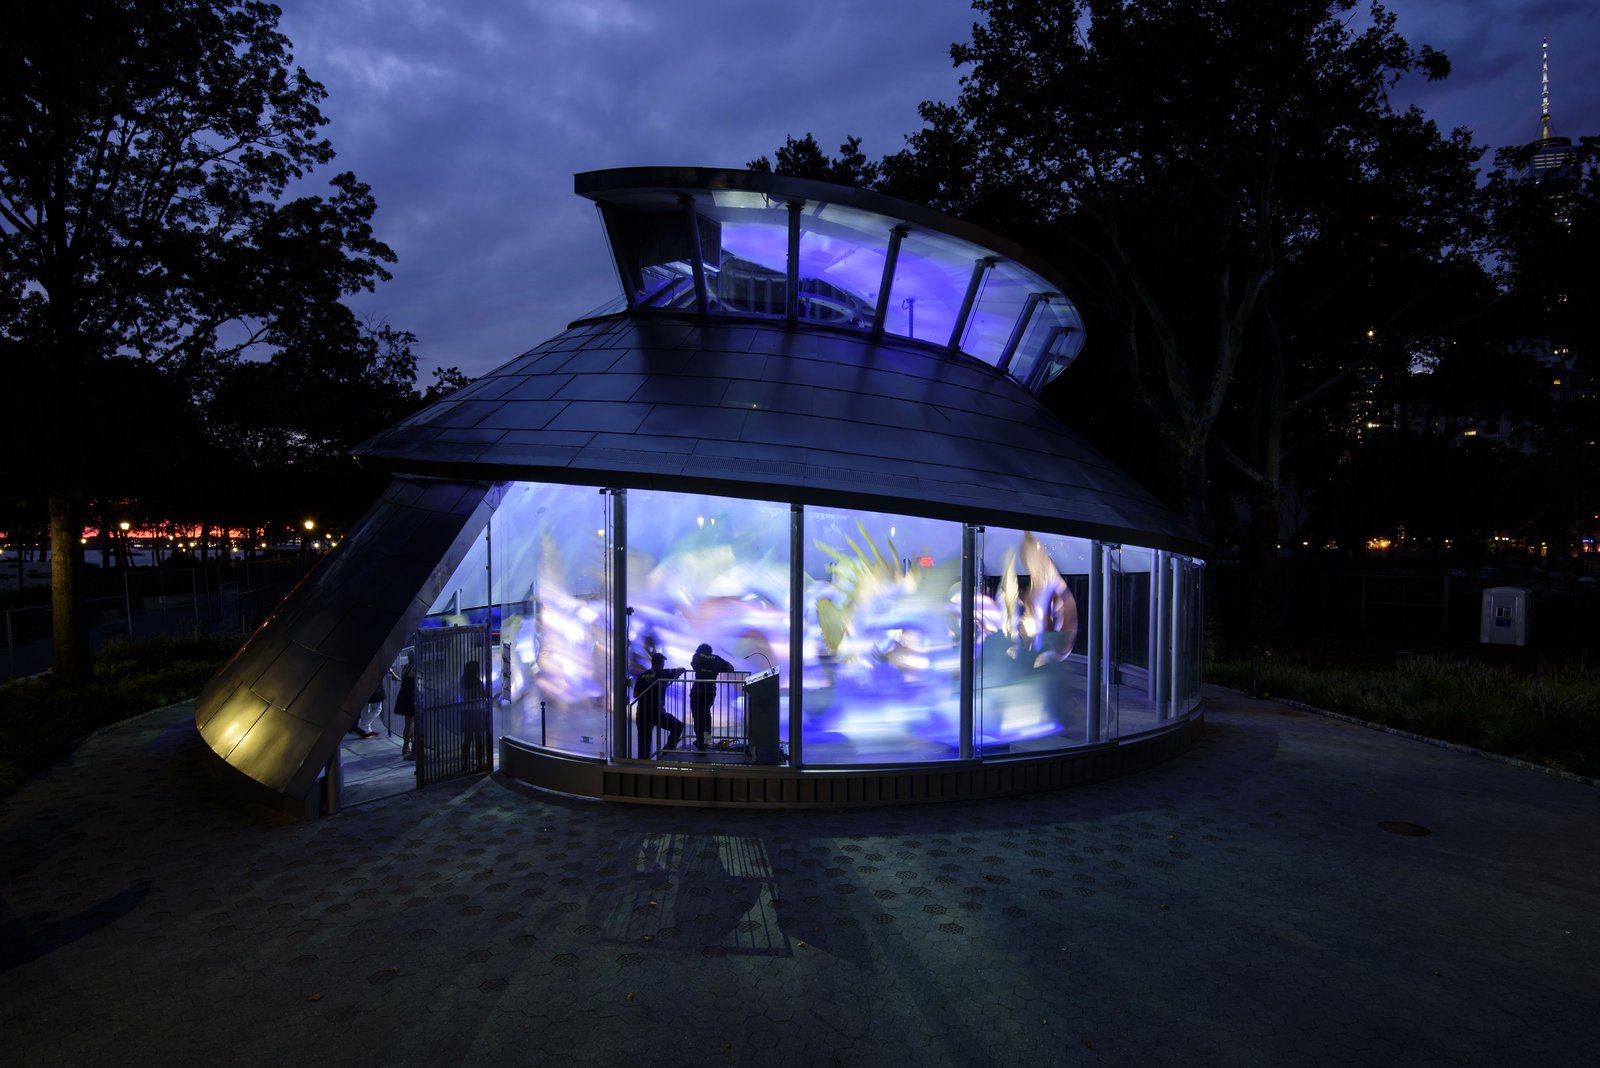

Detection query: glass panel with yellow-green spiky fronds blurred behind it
(802, 508), (962, 766)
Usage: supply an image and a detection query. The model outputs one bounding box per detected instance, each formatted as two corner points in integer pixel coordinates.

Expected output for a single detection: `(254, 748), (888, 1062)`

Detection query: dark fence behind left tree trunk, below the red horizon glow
(0, 560), (301, 678)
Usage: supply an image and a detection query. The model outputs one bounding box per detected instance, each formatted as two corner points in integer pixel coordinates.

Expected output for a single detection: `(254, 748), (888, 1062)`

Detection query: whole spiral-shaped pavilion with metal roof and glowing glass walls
(195, 168), (1205, 815)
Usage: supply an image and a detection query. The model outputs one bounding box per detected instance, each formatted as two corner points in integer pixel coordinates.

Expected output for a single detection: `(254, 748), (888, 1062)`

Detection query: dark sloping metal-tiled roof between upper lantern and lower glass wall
(355, 313), (1205, 553)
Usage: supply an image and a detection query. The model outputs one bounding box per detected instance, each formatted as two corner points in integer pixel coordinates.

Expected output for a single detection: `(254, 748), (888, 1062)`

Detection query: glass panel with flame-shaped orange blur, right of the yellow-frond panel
(973, 526), (1093, 756)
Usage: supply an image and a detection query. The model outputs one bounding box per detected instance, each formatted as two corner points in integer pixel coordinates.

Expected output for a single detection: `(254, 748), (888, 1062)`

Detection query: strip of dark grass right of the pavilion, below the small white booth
(1206, 656), (1600, 777)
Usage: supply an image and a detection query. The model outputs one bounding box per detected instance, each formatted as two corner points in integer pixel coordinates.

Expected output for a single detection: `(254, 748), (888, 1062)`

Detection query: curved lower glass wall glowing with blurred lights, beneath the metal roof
(424, 481), (1203, 767)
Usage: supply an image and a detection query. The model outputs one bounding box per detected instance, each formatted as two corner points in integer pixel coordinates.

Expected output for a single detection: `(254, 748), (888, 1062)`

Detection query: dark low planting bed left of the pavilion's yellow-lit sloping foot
(0, 635), (238, 795)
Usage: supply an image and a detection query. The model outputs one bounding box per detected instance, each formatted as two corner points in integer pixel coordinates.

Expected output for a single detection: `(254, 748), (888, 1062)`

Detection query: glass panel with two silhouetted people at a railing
(627, 489), (790, 748)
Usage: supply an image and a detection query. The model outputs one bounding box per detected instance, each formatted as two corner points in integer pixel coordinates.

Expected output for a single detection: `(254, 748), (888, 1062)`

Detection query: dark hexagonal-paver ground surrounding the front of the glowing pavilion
(0, 691), (1600, 1066)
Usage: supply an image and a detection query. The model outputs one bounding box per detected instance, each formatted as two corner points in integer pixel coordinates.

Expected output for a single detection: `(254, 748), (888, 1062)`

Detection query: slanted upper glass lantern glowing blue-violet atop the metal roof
(579, 171), (1083, 393)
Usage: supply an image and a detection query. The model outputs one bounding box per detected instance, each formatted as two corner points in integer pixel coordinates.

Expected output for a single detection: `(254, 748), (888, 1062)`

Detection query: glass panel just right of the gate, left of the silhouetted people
(474, 483), (611, 756)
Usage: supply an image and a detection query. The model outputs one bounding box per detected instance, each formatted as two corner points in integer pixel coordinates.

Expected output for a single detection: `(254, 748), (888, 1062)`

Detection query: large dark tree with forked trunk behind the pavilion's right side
(882, 0), (1480, 645)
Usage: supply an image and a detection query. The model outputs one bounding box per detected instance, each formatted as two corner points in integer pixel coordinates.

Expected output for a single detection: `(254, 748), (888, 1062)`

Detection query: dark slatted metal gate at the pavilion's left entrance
(416, 627), (494, 787)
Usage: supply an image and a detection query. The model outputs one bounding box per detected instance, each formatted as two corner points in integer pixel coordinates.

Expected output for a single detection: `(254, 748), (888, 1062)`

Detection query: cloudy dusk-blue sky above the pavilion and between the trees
(278, 0), (1600, 382)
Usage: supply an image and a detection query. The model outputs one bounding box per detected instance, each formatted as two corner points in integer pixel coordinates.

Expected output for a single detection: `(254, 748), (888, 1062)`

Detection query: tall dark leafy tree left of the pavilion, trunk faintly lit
(0, 0), (394, 683)
